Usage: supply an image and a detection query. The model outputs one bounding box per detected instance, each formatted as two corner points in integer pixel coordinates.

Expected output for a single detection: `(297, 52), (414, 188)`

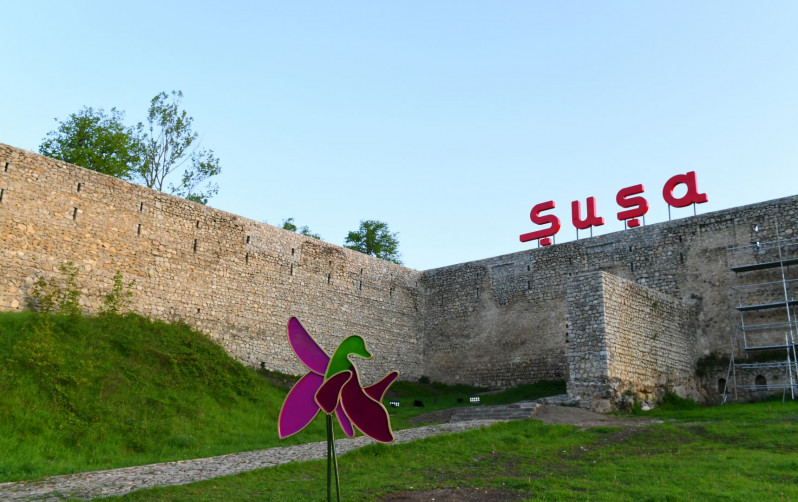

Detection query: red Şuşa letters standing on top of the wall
(520, 171), (708, 246)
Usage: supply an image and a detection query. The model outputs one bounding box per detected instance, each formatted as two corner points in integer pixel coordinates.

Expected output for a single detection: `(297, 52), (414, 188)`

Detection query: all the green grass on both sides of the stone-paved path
(6, 313), (798, 501)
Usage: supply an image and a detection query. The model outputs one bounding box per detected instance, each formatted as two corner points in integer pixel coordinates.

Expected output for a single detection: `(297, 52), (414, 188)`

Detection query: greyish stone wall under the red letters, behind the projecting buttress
(421, 194), (798, 386)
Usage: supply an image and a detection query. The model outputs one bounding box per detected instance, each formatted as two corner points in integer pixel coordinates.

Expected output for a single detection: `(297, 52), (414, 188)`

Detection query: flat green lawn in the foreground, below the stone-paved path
(108, 401), (798, 501)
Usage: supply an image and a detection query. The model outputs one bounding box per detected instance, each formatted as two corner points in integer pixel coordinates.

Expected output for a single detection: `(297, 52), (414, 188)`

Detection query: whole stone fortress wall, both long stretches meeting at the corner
(0, 144), (798, 406)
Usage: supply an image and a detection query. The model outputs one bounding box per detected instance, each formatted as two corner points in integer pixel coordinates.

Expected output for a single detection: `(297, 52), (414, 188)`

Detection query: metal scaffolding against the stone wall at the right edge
(723, 222), (798, 403)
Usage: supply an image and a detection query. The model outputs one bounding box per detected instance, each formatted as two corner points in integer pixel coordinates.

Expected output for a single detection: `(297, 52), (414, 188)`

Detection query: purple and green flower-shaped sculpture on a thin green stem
(277, 317), (399, 502)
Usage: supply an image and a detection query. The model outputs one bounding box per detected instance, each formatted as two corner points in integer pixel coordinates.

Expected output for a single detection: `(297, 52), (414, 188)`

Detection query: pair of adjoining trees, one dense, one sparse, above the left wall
(39, 91), (221, 204)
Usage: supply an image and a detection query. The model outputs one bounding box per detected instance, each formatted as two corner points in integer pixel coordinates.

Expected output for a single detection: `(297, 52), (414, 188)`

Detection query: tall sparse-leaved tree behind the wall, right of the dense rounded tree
(136, 91), (221, 204)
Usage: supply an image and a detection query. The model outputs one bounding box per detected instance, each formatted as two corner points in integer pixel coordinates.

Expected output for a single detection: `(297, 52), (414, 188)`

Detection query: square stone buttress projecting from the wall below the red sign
(568, 272), (699, 411)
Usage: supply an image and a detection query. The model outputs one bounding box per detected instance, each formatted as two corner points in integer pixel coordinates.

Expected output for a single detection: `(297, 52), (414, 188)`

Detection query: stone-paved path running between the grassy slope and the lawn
(0, 420), (497, 501)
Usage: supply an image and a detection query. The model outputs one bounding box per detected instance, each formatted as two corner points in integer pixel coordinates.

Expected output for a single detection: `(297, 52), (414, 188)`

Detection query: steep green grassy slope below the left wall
(0, 312), (325, 481)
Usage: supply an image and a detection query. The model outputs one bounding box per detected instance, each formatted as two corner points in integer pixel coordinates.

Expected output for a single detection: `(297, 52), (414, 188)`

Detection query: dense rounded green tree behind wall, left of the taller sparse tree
(39, 106), (140, 179)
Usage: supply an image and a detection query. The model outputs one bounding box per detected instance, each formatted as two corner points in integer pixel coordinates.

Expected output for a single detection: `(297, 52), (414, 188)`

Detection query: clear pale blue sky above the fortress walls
(0, 0), (798, 270)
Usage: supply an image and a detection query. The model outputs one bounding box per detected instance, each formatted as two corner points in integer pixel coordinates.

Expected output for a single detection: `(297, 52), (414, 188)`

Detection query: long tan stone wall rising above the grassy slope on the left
(0, 144), (422, 379)
